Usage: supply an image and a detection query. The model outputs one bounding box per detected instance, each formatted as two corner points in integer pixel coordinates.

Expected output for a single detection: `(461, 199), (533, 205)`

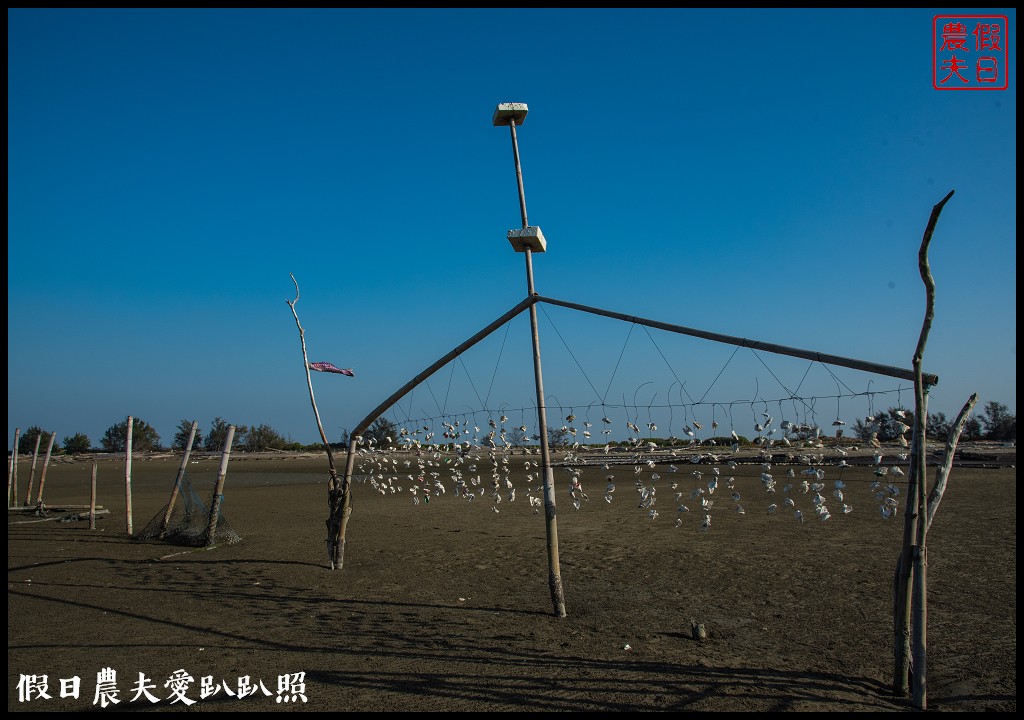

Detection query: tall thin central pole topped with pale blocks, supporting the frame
(509, 115), (565, 618)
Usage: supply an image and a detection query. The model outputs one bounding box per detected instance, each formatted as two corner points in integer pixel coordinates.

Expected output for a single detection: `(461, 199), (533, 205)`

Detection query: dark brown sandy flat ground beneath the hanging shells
(7, 450), (1017, 711)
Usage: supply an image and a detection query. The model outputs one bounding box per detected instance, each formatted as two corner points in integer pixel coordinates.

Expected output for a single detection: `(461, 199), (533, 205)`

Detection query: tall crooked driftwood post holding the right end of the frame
(893, 190), (966, 710)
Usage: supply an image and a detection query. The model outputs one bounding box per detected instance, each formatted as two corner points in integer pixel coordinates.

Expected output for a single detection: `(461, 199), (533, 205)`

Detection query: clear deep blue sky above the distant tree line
(7, 9), (1017, 446)
